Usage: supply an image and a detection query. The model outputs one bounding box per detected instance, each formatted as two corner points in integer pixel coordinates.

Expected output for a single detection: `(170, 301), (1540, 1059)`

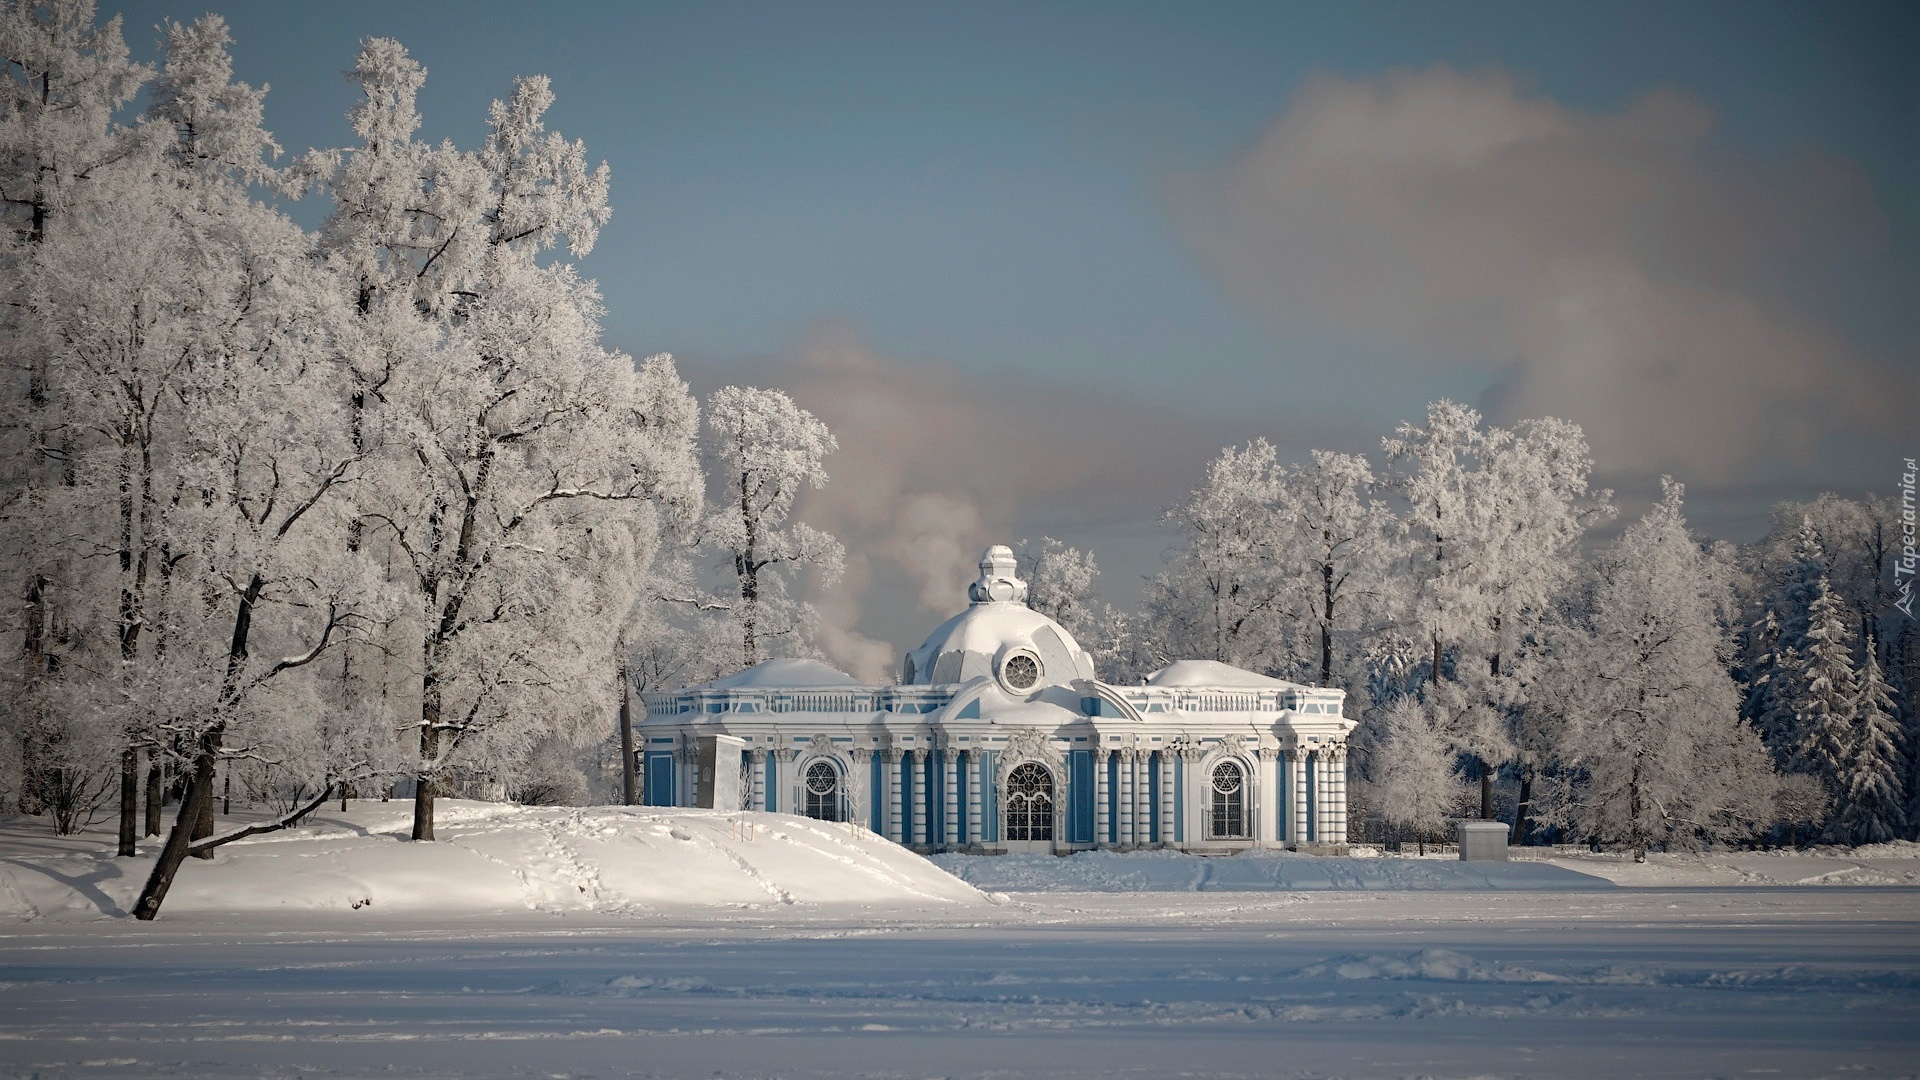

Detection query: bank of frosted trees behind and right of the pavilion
(1027, 402), (1920, 857)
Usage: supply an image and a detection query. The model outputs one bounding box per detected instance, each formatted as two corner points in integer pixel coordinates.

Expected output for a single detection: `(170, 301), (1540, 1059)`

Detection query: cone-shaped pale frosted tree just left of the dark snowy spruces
(1546, 480), (1772, 859)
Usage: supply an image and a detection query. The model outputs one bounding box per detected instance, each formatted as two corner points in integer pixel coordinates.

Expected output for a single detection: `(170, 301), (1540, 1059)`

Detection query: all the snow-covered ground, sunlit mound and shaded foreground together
(0, 801), (1920, 1080)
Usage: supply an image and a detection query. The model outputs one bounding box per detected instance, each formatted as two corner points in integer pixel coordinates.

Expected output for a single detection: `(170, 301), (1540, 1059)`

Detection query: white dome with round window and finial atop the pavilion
(900, 544), (1092, 684)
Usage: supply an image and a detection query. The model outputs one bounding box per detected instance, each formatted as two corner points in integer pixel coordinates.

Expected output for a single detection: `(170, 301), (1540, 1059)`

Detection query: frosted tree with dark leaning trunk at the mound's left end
(134, 171), (363, 919)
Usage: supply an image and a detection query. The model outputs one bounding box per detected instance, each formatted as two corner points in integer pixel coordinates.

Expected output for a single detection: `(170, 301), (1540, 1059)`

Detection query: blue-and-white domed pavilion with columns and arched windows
(636, 546), (1354, 853)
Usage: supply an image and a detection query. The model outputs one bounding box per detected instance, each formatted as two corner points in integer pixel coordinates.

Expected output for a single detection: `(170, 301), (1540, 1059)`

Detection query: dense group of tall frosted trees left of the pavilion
(0, 0), (841, 917)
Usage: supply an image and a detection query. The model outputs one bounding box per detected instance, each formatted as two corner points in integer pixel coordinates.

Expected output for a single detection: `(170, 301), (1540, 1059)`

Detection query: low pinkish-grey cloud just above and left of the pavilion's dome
(684, 323), (1338, 676)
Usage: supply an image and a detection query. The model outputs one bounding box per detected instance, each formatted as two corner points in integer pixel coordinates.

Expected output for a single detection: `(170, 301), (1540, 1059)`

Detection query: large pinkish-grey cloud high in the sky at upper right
(1179, 67), (1908, 480)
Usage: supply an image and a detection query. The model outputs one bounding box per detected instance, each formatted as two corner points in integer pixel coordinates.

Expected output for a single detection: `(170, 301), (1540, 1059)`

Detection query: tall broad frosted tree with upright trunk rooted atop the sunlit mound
(307, 38), (697, 840)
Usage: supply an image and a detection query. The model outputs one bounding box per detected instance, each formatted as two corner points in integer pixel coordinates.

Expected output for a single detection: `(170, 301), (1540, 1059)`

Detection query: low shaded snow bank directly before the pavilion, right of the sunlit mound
(931, 851), (1613, 892)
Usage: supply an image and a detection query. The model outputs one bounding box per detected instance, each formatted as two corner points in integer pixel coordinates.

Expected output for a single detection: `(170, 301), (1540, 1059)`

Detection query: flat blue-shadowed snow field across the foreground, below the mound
(0, 888), (1920, 1080)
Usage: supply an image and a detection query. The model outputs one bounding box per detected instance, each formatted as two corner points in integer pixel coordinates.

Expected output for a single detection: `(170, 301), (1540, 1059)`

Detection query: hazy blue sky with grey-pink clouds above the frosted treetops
(104, 0), (1920, 653)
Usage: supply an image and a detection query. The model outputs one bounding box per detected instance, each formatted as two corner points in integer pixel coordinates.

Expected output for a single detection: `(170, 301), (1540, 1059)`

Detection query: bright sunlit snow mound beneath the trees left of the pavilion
(0, 799), (991, 919)
